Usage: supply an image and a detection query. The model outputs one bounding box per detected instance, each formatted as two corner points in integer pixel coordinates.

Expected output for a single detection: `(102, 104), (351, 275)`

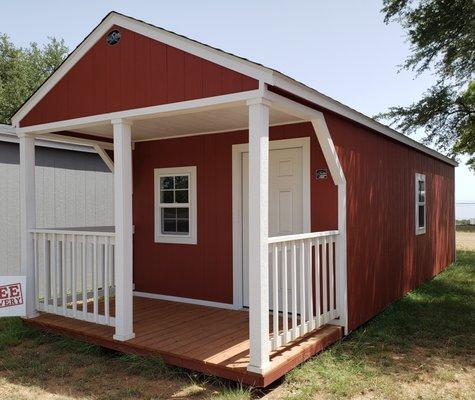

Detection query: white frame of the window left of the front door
(154, 166), (198, 244)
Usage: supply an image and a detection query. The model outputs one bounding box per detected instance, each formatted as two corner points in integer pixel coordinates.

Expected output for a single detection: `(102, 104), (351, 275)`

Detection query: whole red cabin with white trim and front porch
(13, 12), (456, 386)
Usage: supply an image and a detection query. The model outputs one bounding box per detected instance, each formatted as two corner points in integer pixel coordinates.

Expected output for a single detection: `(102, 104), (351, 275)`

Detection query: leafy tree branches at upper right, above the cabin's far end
(376, 0), (475, 169)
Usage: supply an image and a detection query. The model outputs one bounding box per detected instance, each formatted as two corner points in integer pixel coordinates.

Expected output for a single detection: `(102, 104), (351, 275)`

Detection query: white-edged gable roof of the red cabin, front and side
(12, 11), (458, 166)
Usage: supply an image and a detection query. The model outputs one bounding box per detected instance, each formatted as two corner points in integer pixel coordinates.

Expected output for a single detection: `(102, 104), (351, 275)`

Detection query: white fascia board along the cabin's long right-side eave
(272, 72), (458, 167)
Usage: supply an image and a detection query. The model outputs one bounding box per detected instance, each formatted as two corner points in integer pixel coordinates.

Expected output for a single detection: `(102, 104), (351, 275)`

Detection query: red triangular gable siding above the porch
(20, 27), (258, 126)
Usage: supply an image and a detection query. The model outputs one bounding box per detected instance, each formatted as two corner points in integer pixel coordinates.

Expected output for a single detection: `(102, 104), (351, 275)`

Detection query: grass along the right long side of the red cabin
(269, 251), (475, 399)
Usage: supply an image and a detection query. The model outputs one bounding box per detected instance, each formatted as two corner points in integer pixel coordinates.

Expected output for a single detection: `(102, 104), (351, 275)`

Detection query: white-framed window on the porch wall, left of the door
(155, 167), (197, 244)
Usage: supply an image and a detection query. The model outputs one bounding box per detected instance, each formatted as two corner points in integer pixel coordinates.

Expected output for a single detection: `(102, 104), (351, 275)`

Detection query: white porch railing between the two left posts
(31, 229), (115, 326)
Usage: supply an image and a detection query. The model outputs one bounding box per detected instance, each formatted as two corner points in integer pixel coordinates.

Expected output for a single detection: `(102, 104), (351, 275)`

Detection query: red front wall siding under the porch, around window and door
(133, 124), (337, 303)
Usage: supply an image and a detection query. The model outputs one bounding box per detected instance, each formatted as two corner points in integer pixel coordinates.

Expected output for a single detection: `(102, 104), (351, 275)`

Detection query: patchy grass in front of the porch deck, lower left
(0, 318), (245, 400)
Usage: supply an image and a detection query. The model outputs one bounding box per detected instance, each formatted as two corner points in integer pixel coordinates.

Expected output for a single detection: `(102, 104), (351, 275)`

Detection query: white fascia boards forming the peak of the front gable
(12, 13), (272, 127)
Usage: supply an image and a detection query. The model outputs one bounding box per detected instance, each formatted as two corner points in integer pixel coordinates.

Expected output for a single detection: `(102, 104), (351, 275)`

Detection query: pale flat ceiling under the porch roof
(73, 105), (301, 141)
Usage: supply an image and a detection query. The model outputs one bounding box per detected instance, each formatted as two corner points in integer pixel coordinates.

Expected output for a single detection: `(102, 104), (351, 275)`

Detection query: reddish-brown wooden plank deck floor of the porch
(26, 297), (342, 387)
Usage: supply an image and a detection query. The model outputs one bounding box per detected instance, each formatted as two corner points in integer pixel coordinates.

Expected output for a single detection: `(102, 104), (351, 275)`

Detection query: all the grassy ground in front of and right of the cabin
(0, 251), (475, 400)
